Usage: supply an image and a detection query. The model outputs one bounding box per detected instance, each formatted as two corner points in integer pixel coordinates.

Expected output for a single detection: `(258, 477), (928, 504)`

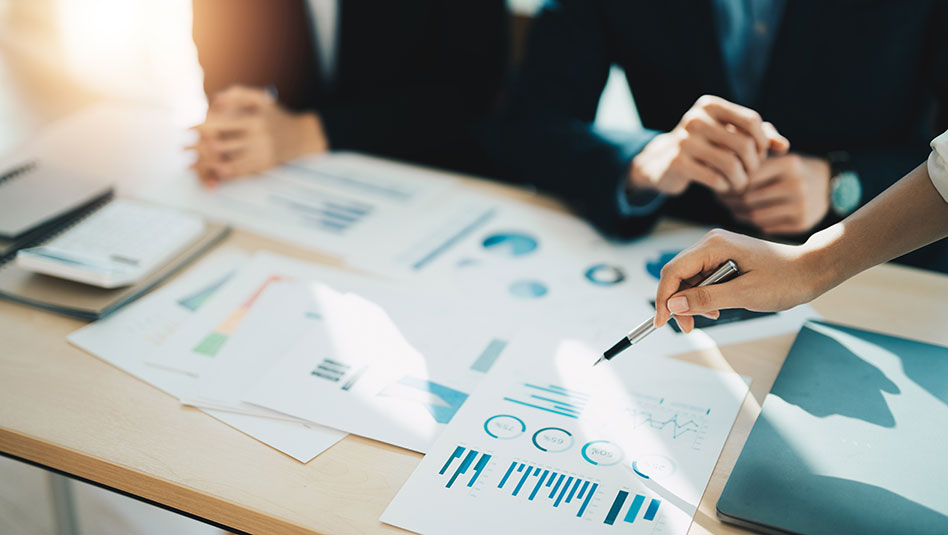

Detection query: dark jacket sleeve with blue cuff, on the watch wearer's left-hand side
(489, 0), (660, 236)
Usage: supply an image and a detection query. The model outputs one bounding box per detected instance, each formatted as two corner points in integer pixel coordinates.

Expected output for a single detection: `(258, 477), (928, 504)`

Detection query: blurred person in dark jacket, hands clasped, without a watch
(192, 0), (507, 185)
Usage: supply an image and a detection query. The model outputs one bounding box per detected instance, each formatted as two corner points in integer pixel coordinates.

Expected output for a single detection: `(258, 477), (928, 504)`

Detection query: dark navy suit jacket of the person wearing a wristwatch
(489, 0), (948, 268)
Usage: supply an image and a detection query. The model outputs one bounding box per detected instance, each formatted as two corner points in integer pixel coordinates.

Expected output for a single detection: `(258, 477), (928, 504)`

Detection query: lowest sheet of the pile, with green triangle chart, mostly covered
(68, 253), (345, 463)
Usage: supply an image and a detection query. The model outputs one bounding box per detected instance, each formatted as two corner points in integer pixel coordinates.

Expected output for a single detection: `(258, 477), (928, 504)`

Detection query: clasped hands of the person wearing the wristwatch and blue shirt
(628, 95), (830, 234)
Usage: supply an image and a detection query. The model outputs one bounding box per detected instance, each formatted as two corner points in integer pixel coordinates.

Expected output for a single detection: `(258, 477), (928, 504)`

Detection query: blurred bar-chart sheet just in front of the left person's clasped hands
(141, 153), (493, 268)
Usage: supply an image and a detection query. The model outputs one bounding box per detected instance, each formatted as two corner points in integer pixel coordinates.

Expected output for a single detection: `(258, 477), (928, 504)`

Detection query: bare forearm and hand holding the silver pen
(655, 132), (948, 332)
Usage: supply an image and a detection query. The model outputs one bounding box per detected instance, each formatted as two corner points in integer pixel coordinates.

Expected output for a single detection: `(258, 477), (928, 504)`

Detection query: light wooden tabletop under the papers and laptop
(0, 174), (948, 534)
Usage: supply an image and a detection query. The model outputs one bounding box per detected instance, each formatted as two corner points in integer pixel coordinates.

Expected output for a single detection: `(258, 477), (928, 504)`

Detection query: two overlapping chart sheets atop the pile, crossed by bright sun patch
(150, 252), (510, 452)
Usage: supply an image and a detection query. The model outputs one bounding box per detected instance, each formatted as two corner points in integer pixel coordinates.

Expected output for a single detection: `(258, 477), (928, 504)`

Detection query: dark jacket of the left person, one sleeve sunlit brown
(193, 0), (508, 173)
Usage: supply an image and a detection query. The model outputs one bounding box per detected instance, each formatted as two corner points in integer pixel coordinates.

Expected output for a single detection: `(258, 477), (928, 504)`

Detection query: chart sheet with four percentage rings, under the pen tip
(381, 333), (748, 535)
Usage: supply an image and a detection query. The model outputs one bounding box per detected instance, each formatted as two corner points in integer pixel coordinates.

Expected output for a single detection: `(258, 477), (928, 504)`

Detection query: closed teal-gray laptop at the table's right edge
(717, 322), (948, 535)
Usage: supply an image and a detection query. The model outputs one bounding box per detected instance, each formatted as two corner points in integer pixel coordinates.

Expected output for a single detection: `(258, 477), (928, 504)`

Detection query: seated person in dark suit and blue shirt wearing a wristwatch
(489, 0), (948, 270)
